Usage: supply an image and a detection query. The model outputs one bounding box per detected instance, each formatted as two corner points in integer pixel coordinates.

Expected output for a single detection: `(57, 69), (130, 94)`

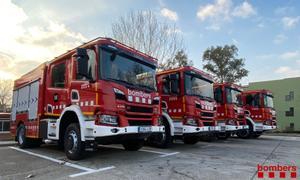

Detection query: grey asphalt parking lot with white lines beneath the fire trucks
(0, 136), (300, 180)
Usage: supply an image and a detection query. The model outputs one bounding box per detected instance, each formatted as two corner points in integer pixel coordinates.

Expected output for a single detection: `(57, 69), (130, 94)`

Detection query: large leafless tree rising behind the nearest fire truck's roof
(112, 11), (183, 69)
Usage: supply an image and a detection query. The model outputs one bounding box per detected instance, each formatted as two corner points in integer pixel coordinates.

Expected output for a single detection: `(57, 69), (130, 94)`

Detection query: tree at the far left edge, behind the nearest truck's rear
(0, 79), (12, 112)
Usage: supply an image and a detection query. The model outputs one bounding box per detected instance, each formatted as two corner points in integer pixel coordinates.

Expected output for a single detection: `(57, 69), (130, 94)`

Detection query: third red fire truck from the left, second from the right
(214, 83), (248, 139)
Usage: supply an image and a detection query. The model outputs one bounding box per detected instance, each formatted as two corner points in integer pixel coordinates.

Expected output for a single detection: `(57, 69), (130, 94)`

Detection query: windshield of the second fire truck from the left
(185, 74), (214, 99)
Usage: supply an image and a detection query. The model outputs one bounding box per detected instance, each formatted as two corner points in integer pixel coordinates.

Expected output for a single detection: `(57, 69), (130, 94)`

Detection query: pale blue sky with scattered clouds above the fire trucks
(0, 0), (300, 84)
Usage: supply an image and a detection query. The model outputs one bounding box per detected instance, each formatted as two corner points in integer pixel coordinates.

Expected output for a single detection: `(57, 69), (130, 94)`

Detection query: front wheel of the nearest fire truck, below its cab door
(64, 123), (85, 160)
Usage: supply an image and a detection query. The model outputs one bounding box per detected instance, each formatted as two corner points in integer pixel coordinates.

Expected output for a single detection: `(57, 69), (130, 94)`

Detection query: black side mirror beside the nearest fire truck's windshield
(76, 48), (90, 79)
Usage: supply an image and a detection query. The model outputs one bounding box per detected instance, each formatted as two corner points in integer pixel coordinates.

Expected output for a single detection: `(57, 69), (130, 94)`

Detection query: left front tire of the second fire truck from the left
(148, 119), (173, 148)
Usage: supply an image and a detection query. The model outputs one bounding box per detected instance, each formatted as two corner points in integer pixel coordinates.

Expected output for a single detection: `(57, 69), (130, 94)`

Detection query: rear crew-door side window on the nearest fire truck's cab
(51, 63), (66, 88)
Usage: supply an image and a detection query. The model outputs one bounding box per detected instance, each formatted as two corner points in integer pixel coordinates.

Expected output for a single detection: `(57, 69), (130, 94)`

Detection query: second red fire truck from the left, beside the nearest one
(150, 66), (219, 147)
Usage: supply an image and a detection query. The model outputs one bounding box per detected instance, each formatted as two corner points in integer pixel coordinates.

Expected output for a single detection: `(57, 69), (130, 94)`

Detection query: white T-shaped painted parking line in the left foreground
(10, 146), (115, 177)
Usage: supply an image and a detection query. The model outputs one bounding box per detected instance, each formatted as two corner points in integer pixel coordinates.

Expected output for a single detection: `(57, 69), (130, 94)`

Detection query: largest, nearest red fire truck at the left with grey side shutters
(11, 38), (164, 160)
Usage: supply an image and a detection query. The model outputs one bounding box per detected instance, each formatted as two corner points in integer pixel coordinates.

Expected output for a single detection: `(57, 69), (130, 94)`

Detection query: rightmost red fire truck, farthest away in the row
(242, 89), (276, 138)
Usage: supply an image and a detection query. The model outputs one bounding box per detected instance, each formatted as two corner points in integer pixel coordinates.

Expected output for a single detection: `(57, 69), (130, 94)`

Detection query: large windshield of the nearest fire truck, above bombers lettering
(100, 49), (155, 90)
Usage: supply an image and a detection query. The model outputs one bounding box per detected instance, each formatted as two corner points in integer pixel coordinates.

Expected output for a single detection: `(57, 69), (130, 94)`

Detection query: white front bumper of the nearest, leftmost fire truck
(91, 125), (165, 138)
